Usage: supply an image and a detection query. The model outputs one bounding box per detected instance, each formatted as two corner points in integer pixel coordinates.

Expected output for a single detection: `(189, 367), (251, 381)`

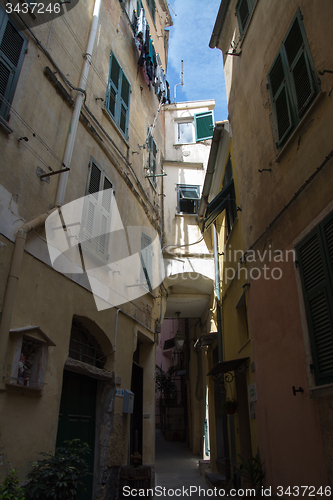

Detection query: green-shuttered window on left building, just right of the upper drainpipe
(105, 52), (131, 138)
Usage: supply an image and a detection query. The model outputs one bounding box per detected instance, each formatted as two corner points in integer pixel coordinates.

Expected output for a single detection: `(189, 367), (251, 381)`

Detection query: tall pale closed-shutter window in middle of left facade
(81, 160), (113, 260)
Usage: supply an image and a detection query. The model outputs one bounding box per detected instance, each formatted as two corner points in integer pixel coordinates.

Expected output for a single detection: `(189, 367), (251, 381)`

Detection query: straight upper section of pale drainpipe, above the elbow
(55, 0), (101, 207)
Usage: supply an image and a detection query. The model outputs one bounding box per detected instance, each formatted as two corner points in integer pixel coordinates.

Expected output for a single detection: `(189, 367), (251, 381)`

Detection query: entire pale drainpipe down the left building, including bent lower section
(0, 0), (101, 389)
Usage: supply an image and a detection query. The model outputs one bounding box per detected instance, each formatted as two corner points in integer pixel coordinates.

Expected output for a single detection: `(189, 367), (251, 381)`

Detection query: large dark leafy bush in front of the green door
(26, 439), (90, 500)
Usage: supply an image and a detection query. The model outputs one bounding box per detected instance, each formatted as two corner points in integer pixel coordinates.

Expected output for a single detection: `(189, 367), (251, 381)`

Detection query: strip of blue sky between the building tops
(167, 0), (228, 121)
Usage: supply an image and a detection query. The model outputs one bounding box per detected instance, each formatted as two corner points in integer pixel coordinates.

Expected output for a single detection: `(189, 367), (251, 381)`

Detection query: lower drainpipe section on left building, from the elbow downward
(0, 208), (56, 388)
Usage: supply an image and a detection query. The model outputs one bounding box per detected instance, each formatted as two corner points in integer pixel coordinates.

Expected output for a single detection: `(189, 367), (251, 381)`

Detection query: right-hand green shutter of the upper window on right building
(284, 17), (316, 117)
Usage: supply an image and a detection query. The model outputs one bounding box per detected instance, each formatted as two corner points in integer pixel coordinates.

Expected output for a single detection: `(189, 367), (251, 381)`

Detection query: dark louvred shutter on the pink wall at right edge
(297, 214), (333, 385)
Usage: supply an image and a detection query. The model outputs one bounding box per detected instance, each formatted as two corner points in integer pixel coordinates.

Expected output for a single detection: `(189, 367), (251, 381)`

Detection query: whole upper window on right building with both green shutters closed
(267, 11), (319, 147)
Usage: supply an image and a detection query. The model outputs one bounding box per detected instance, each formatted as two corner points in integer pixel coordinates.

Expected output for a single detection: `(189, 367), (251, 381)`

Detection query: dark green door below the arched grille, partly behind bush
(57, 371), (97, 500)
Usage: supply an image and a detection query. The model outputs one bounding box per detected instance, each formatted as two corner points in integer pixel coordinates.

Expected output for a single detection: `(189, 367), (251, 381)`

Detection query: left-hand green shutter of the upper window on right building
(268, 51), (293, 145)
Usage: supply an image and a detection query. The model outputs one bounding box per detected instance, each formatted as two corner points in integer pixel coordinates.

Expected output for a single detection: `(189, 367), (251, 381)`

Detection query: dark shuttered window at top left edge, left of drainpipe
(0, 7), (28, 120)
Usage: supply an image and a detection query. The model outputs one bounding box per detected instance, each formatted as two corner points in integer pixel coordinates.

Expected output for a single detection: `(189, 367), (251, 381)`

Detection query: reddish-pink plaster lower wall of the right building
(248, 256), (328, 490)
